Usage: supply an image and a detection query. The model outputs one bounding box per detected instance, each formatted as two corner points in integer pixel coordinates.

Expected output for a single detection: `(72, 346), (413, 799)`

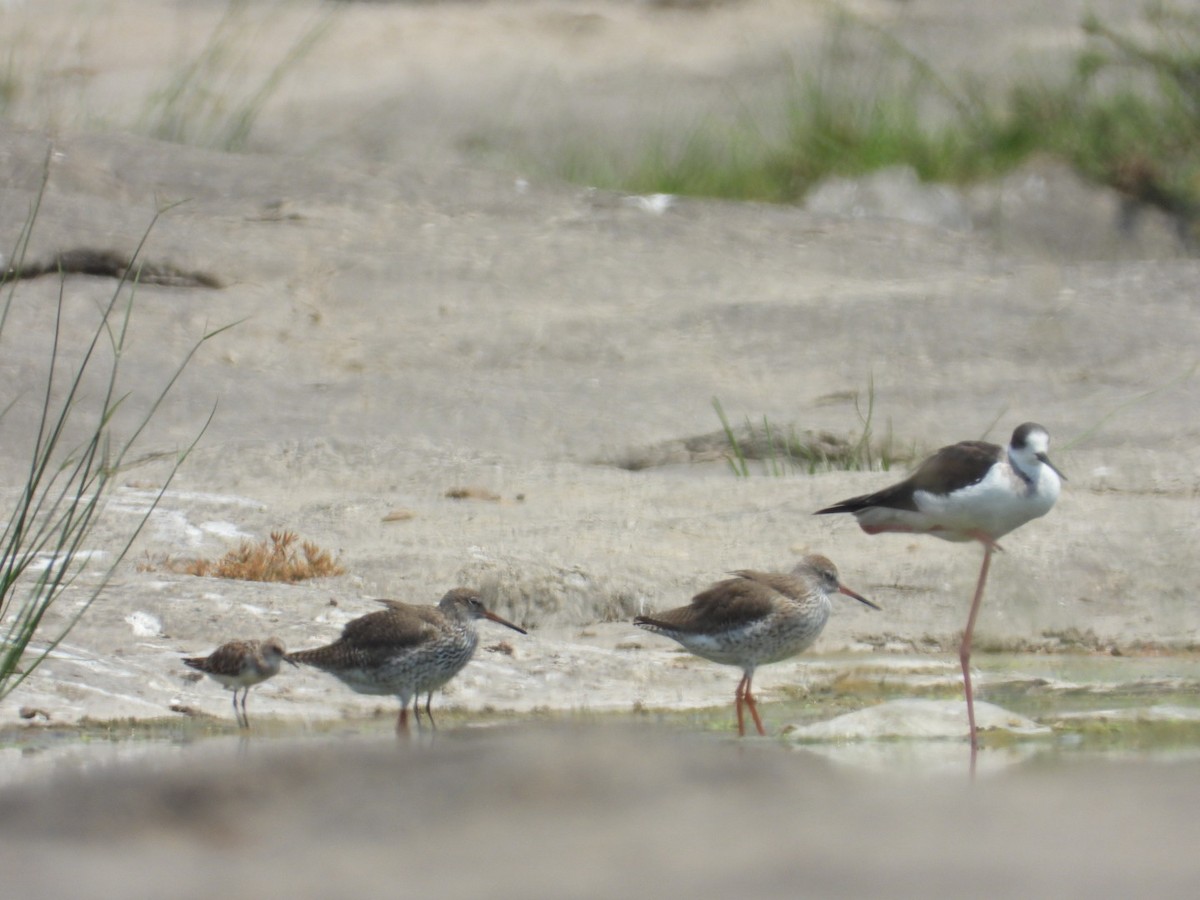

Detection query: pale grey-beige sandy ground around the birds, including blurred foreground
(0, 0), (1200, 896)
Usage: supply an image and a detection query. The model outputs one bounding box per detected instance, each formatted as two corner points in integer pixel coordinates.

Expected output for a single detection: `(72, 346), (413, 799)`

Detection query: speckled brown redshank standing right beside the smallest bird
(288, 588), (528, 732)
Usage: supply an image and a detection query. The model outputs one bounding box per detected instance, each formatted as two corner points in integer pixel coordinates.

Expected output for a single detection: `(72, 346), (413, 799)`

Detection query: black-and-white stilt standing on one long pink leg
(814, 422), (1067, 763)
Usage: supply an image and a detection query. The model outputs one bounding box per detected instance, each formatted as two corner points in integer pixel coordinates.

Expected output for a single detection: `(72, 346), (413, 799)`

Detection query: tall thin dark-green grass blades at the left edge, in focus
(0, 157), (223, 697)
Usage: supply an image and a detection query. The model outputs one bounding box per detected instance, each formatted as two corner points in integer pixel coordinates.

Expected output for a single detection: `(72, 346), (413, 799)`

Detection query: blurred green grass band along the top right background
(557, 4), (1200, 227)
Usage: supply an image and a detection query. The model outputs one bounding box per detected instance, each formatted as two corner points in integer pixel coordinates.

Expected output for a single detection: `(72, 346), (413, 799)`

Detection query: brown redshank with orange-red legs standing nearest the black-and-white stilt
(634, 554), (880, 737)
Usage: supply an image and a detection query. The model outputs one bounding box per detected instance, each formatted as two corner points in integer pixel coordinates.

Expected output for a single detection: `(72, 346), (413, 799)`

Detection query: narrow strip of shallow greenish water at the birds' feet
(0, 654), (1200, 786)
